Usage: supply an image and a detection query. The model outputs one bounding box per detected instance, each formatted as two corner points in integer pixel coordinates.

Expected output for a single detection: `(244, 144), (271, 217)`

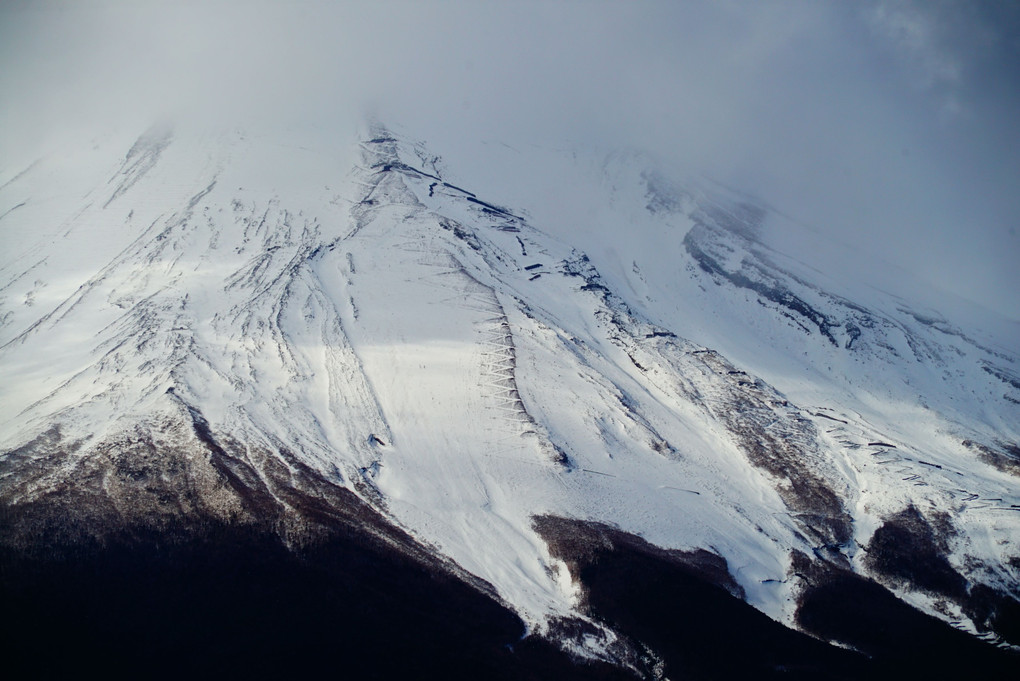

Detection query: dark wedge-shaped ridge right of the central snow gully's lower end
(534, 516), (873, 679)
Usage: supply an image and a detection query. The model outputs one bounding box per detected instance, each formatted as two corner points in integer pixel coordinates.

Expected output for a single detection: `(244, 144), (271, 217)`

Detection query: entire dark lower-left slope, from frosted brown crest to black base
(0, 418), (632, 680)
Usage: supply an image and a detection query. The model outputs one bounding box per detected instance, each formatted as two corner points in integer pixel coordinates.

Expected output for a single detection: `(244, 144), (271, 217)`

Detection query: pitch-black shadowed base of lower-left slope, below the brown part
(0, 523), (630, 679)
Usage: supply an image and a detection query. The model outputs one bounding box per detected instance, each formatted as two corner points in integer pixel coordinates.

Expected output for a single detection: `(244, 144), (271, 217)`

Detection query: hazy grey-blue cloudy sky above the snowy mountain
(0, 0), (1020, 319)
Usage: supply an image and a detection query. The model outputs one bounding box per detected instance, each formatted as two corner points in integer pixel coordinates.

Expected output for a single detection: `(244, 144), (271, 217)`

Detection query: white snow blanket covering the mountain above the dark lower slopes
(0, 127), (1020, 640)
